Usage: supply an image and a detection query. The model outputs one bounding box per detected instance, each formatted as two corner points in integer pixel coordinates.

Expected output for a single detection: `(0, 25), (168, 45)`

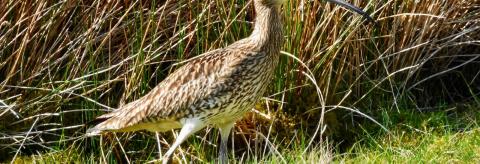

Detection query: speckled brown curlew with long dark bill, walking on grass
(87, 0), (372, 163)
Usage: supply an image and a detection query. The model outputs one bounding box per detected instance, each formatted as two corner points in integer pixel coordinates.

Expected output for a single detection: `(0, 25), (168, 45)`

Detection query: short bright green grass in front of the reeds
(11, 104), (480, 163)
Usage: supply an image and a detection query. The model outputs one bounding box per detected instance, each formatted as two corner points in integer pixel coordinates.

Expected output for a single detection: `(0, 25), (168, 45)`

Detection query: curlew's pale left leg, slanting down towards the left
(162, 119), (205, 164)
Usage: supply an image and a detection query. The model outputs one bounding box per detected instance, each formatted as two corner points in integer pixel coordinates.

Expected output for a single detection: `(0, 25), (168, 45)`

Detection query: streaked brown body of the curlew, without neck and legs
(87, 1), (283, 131)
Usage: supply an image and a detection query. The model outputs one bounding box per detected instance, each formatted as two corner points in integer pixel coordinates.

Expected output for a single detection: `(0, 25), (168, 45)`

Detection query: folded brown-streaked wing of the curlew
(88, 49), (256, 133)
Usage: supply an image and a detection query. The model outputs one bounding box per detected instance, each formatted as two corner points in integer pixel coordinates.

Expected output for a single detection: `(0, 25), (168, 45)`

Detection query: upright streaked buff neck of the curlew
(249, 4), (283, 53)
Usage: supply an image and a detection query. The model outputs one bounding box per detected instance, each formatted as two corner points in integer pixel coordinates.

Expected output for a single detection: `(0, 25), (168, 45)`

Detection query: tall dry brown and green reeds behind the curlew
(0, 0), (480, 162)
